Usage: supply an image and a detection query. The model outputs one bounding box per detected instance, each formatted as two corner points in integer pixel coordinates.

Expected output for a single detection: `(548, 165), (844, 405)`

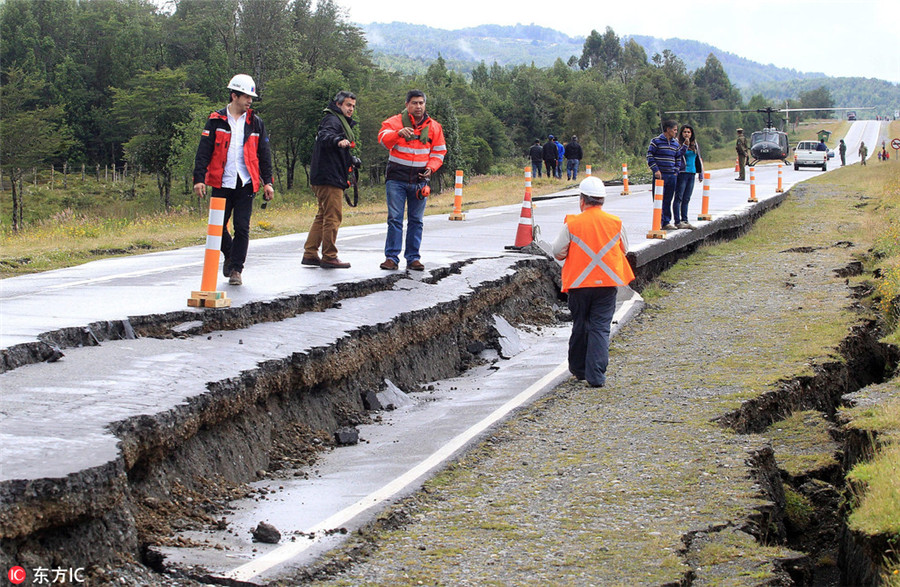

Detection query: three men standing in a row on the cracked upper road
(193, 74), (447, 285)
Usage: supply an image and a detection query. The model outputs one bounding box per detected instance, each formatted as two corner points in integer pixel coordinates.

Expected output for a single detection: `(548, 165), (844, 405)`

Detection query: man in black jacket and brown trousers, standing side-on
(301, 91), (357, 269)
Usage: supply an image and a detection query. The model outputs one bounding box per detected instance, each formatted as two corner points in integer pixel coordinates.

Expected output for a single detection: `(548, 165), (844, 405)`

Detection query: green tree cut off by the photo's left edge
(0, 69), (71, 232)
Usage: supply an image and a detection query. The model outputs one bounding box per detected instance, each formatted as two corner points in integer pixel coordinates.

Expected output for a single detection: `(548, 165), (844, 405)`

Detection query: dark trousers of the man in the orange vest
(569, 287), (617, 385)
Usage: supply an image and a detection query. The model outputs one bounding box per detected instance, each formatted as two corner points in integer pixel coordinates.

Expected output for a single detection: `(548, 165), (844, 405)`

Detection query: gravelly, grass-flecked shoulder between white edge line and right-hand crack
(300, 185), (896, 585)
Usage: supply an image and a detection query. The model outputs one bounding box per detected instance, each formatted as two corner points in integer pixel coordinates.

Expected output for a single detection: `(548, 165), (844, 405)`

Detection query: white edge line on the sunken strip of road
(225, 298), (640, 581)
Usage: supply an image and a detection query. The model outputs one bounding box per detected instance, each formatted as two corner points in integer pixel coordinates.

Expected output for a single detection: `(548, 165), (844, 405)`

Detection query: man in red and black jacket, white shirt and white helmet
(194, 74), (275, 285)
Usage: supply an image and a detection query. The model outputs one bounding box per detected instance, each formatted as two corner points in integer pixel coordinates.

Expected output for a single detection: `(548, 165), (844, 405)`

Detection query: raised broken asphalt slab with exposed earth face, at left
(0, 254), (559, 580)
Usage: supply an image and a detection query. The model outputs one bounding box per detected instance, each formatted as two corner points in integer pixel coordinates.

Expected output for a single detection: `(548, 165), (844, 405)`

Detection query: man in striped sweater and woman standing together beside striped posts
(647, 120), (703, 230)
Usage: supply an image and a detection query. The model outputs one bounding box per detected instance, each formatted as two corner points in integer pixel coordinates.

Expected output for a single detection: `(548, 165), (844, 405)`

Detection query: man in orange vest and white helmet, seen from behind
(553, 177), (634, 387)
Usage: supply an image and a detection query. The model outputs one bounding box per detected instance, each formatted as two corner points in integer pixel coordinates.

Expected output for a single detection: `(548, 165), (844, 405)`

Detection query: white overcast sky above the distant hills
(335, 0), (900, 83)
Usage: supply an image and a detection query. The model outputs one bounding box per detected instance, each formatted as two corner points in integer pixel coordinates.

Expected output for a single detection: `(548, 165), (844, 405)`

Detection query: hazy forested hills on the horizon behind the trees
(360, 22), (825, 89)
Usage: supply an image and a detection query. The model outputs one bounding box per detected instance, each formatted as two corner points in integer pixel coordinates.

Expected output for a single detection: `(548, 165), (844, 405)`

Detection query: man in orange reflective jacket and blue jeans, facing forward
(378, 90), (447, 271)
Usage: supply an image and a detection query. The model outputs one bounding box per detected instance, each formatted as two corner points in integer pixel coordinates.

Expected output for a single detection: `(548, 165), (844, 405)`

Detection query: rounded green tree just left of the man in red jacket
(112, 68), (204, 212)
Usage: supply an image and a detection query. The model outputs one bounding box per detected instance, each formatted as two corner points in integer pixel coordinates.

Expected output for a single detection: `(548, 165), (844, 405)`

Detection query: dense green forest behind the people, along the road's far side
(0, 0), (884, 227)
